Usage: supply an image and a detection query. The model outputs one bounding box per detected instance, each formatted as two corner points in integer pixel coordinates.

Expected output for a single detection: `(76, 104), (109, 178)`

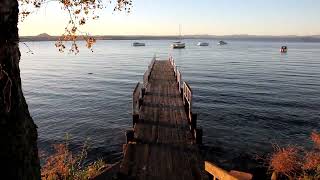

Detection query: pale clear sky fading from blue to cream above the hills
(19, 0), (320, 36)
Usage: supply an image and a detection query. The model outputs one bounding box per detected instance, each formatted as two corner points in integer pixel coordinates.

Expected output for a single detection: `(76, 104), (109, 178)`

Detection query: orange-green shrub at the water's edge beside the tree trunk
(41, 136), (107, 180)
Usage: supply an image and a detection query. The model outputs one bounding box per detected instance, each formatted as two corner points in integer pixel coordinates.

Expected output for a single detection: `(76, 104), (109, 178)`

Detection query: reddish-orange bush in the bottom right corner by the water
(269, 132), (320, 180)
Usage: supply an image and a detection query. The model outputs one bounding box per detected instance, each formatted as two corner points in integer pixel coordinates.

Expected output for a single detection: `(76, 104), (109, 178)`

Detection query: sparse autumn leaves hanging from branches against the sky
(18, 0), (132, 54)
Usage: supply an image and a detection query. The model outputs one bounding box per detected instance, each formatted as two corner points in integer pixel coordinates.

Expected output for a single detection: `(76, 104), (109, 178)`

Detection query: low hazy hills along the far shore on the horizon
(20, 33), (320, 42)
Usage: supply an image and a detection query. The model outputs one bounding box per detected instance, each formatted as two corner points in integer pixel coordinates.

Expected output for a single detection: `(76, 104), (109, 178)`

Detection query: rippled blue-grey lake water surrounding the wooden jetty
(20, 40), (320, 167)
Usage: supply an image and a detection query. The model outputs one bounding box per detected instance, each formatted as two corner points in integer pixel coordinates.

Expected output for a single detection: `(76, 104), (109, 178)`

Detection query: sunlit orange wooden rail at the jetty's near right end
(204, 161), (240, 180)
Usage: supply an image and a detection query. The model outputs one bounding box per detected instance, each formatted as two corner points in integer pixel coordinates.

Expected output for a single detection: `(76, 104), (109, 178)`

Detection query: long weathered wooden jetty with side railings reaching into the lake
(95, 57), (252, 180)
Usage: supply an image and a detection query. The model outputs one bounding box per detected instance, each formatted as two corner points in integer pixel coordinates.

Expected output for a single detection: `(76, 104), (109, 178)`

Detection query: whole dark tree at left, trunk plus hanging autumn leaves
(0, 0), (131, 179)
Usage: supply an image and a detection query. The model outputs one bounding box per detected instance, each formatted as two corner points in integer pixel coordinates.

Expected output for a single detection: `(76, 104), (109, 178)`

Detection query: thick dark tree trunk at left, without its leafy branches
(0, 0), (40, 179)
